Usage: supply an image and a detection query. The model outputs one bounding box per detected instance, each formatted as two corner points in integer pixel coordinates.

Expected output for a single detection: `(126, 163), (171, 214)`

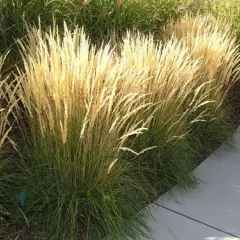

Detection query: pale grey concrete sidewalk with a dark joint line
(143, 127), (240, 240)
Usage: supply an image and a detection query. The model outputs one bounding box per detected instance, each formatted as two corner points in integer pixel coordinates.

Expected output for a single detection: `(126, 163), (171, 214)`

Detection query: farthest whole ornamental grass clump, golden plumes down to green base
(166, 15), (239, 154)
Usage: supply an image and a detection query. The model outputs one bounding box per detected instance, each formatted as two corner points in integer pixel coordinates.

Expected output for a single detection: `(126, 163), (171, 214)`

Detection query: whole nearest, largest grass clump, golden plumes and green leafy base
(4, 26), (156, 239)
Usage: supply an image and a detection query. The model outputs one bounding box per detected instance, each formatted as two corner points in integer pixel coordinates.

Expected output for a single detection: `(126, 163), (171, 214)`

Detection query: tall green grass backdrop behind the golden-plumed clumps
(0, 0), (187, 68)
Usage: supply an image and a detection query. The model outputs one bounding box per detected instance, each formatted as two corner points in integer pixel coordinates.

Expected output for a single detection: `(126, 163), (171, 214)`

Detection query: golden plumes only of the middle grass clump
(121, 33), (211, 142)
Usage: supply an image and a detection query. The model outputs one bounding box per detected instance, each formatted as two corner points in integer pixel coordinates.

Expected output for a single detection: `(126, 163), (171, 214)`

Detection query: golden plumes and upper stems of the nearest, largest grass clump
(15, 26), (155, 179)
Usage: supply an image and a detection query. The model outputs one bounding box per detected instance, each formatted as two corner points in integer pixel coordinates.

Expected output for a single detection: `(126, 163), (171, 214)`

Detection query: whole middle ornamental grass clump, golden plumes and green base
(118, 34), (212, 192)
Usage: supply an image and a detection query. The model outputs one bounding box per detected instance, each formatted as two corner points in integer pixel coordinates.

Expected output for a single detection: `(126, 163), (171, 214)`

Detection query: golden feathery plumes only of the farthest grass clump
(166, 14), (239, 105)
